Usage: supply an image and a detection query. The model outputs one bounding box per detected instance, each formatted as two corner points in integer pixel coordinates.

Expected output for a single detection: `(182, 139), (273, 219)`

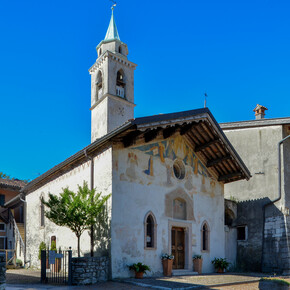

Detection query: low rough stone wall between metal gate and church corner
(72, 257), (109, 285)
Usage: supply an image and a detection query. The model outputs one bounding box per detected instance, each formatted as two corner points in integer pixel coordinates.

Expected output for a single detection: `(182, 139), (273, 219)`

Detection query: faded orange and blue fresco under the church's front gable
(114, 136), (215, 195)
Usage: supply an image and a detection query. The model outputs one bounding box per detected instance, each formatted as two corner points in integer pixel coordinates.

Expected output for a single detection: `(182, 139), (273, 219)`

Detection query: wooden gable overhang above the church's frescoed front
(125, 108), (251, 183)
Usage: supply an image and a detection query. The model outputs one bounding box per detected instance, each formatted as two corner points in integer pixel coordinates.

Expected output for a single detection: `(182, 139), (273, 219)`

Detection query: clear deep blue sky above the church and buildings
(0, 0), (290, 179)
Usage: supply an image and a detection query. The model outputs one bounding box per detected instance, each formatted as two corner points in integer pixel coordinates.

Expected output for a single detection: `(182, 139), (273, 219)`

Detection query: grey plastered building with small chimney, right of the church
(220, 105), (290, 274)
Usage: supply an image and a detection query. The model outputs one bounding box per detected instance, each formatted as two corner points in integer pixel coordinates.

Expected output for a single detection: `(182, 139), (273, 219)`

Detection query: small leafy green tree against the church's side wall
(41, 181), (111, 256)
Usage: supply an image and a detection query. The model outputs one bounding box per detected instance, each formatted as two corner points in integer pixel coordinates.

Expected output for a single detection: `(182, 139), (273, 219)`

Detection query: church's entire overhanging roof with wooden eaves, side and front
(23, 108), (251, 194)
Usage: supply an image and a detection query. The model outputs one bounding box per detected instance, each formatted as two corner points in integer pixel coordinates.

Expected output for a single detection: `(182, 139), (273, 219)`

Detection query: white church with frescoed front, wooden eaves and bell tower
(24, 10), (250, 278)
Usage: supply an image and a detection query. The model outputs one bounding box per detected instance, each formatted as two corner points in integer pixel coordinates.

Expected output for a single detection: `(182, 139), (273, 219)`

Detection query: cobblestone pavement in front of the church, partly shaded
(6, 269), (290, 290)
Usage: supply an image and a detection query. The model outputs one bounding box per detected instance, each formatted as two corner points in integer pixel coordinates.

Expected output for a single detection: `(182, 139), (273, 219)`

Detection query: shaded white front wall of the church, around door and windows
(111, 136), (225, 278)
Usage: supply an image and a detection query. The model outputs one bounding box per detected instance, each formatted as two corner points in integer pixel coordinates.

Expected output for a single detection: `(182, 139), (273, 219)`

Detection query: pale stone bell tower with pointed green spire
(89, 6), (137, 142)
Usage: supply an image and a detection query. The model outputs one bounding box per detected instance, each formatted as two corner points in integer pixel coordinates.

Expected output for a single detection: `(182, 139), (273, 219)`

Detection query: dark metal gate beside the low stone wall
(41, 250), (72, 285)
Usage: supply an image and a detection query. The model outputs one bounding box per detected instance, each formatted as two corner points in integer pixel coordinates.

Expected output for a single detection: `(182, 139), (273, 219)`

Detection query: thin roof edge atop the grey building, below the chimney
(220, 117), (290, 129)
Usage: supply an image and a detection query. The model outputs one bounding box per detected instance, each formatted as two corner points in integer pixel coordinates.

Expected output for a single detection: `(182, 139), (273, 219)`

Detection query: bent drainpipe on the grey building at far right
(261, 135), (290, 270)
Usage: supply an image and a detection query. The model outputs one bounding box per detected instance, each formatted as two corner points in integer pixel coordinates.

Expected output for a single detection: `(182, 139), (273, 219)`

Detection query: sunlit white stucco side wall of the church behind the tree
(26, 148), (112, 267)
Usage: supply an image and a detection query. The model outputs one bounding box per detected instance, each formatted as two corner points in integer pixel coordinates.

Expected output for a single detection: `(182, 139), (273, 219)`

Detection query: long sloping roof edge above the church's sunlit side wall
(21, 121), (132, 193)
